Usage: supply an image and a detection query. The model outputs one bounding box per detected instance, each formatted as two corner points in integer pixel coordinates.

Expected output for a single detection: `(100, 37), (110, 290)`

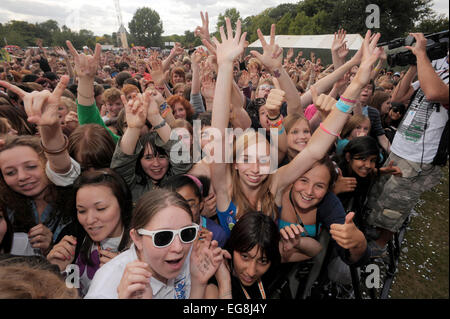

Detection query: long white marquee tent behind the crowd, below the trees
(248, 34), (364, 50)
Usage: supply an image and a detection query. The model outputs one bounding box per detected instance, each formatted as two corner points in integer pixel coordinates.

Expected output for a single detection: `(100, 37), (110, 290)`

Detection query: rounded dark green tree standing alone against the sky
(128, 7), (164, 47)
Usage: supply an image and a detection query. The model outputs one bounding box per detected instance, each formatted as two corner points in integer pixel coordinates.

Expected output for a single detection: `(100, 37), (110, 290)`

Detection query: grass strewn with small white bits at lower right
(390, 165), (449, 299)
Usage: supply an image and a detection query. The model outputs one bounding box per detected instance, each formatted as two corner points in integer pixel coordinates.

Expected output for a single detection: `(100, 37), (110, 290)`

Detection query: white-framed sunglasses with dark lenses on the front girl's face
(137, 224), (199, 248)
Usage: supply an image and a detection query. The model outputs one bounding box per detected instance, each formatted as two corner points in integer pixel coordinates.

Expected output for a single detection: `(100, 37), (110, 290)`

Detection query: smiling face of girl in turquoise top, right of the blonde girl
(292, 165), (331, 210)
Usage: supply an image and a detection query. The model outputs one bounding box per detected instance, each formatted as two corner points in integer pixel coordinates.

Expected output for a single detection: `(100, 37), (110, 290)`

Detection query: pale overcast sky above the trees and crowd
(0, 0), (449, 35)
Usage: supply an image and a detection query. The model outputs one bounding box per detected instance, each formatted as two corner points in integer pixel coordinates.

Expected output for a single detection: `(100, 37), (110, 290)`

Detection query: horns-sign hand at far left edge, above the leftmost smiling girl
(0, 75), (69, 126)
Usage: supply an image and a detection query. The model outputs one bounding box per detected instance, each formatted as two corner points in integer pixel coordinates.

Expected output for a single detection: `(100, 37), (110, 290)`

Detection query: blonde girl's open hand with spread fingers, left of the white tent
(207, 18), (247, 65)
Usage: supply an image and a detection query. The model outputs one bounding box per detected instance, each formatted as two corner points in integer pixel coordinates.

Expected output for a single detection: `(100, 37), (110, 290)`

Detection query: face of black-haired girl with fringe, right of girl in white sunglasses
(233, 245), (271, 286)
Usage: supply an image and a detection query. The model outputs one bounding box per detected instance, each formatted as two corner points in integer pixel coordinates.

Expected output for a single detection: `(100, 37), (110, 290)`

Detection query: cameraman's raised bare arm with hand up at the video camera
(406, 33), (448, 105)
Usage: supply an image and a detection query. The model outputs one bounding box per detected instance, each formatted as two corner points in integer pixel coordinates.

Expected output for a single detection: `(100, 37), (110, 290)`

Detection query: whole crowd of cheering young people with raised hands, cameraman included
(0, 13), (449, 299)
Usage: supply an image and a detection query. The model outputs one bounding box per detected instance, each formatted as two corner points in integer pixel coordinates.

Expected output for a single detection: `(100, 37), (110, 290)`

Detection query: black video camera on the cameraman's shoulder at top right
(378, 30), (449, 68)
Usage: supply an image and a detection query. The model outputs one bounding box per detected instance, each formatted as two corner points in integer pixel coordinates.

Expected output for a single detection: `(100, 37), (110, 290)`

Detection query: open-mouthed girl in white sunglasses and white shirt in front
(85, 189), (230, 299)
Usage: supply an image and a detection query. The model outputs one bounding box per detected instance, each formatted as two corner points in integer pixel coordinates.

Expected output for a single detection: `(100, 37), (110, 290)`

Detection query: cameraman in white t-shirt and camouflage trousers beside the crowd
(367, 33), (449, 258)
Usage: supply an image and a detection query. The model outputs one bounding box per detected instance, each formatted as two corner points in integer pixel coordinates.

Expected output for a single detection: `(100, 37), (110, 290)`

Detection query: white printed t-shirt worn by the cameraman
(391, 70), (449, 164)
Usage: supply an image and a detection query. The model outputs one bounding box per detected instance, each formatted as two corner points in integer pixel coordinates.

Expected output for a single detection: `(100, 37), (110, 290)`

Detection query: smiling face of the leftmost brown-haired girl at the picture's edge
(0, 146), (49, 197)
